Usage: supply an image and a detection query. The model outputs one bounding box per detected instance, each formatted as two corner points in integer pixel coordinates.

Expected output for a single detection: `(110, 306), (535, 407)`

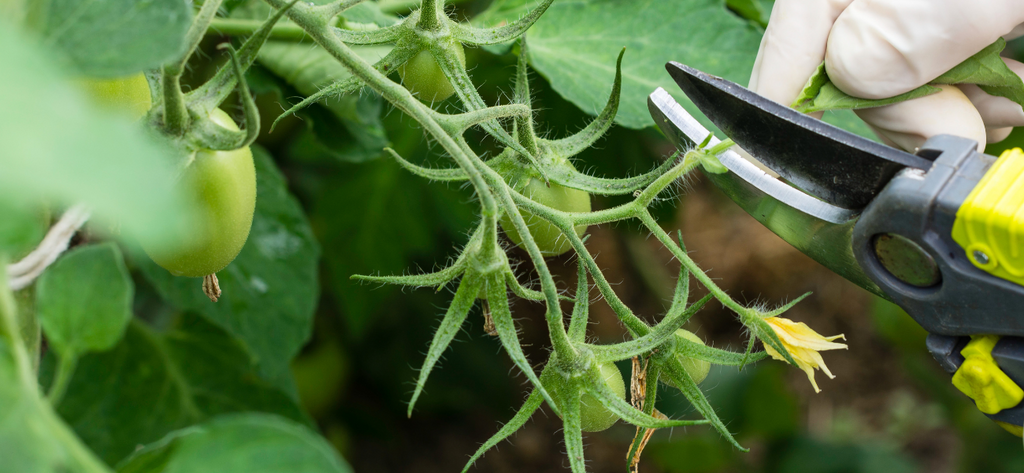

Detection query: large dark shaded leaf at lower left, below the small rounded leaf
(59, 313), (304, 465)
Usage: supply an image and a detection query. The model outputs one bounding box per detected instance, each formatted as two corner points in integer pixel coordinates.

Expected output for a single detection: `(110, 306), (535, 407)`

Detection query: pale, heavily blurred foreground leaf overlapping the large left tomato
(0, 19), (181, 240)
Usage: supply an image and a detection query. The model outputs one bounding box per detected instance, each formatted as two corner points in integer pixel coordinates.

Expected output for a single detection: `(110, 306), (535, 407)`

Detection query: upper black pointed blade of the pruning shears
(666, 62), (932, 209)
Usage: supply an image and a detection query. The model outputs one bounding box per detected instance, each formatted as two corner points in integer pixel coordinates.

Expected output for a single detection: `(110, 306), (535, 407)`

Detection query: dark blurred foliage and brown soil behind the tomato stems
(186, 0), (1024, 473)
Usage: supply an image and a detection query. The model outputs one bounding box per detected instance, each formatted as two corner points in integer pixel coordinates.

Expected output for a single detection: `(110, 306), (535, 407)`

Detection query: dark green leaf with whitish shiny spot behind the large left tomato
(137, 146), (319, 386)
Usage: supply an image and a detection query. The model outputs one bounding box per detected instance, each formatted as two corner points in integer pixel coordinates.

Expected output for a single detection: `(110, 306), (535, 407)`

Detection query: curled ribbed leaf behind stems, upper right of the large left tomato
(259, 41), (391, 163)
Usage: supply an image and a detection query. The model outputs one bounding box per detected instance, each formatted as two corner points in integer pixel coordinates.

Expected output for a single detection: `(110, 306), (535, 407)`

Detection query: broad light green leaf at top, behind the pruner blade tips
(516, 0), (761, 128)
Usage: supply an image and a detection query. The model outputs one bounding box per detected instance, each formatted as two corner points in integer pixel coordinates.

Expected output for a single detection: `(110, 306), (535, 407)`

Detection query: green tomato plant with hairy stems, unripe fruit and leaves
(0, 0), (872, 473)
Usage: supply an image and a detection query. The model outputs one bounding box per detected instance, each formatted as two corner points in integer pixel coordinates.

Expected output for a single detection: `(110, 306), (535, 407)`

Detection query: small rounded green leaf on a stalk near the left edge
(36, 243), (135, 356)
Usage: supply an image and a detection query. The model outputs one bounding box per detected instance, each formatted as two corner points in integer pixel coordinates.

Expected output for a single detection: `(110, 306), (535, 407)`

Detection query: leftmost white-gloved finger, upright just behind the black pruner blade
(749, 0), (853, 105)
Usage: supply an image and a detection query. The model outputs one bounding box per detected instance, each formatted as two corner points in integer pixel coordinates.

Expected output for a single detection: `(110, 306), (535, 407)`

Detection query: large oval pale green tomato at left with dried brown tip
(143, 109), (256, 277)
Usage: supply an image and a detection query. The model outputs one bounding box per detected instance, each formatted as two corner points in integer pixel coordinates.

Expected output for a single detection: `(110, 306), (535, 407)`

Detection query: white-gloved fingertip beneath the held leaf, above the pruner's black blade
(855, 85), (987, 153)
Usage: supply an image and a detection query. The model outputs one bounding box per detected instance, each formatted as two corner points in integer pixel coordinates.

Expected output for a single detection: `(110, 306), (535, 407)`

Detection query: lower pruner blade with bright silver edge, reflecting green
(647, 87), (886, 297)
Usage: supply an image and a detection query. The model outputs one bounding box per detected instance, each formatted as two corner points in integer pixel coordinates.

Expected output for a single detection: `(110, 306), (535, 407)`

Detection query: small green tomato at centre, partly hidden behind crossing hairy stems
(499, 177), (591, 256)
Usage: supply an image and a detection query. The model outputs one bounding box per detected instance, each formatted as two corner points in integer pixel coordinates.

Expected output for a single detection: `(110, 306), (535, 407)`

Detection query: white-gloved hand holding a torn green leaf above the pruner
(750, 0), (1024, 152)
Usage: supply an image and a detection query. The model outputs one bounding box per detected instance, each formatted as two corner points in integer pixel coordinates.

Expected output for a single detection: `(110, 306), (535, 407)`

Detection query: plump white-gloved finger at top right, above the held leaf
(825, 0), (1024, 98)
